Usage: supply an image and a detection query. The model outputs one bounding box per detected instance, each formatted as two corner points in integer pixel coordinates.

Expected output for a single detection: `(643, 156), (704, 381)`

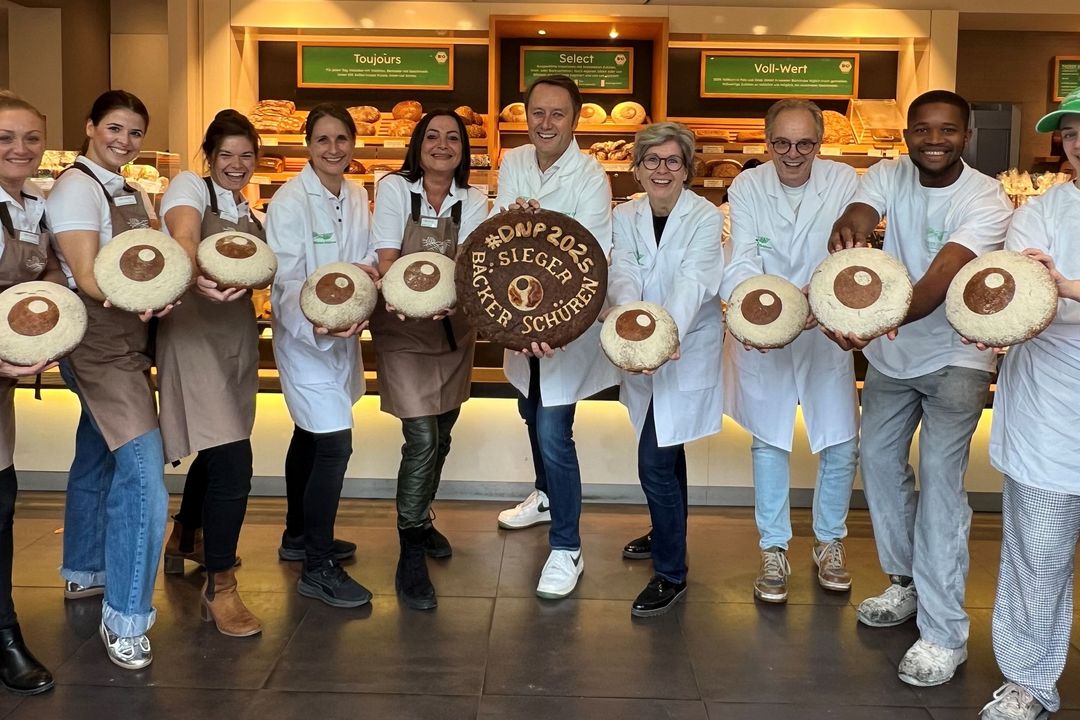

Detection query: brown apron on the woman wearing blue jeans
(60, 163), (158, 450)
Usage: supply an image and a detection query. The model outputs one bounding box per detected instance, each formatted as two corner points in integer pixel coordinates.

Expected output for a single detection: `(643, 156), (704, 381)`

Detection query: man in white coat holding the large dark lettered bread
(492, 76), (618, 598)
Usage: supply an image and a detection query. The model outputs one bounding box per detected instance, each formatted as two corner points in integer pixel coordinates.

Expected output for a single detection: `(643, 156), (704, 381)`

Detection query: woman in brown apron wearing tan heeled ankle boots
(154, 110), (266, 637)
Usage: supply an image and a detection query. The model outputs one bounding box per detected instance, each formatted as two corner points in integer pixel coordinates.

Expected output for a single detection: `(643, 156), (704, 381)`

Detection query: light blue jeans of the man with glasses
(750, 437), (859, 549)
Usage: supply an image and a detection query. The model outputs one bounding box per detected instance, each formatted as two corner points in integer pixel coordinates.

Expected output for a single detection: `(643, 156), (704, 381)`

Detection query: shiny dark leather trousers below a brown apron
(397, 408), (461, 528)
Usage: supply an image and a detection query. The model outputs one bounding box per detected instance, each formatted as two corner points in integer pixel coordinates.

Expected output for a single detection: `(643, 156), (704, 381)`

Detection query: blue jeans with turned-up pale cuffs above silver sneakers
(60, 362), (168, 637)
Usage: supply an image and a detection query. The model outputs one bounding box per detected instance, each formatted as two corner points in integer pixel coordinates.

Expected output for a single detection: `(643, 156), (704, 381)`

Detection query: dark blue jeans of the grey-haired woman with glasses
(637, 403), (687, 583)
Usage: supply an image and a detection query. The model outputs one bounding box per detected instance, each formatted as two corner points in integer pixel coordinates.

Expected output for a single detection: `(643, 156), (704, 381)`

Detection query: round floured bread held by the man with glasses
(726, 275), (810, 350)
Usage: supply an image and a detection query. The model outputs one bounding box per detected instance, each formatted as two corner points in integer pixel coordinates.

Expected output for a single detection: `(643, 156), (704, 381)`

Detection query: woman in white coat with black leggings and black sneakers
(267, 103), (378, 608)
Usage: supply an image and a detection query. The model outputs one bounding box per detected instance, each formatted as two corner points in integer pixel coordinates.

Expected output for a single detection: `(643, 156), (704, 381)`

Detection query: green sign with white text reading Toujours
(296, 43), (454, 90)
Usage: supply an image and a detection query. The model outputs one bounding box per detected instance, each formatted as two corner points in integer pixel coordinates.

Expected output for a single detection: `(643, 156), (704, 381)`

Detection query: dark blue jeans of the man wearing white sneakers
(517, 357), (581, 551)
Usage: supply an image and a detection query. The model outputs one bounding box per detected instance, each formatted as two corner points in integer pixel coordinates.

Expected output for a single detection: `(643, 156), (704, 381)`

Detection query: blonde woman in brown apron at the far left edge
(0, 93), (58, 695)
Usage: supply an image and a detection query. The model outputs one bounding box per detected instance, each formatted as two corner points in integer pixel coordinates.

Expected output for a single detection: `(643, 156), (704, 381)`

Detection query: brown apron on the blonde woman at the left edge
(0, 194), (49, 470)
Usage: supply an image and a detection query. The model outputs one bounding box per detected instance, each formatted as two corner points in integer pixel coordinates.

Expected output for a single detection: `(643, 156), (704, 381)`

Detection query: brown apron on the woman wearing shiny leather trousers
(370, 192), (476, 418)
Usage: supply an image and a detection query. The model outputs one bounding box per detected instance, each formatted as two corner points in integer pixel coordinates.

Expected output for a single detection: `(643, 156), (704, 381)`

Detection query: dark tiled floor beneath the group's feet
(0, 493), (1080, 720)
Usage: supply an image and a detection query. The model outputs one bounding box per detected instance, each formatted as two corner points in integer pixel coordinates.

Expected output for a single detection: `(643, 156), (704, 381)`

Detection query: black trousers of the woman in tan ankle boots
(176, 439), (253, 572)
